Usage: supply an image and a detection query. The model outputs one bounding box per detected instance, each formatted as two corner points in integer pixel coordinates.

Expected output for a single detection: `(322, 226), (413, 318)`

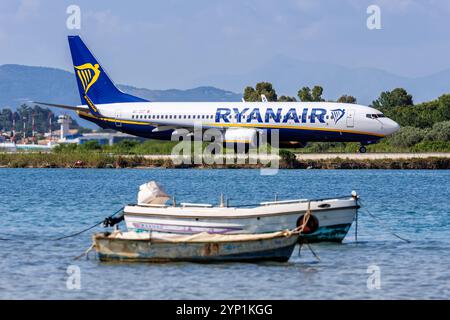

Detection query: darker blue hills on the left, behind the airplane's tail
(0, 64), (241, 127)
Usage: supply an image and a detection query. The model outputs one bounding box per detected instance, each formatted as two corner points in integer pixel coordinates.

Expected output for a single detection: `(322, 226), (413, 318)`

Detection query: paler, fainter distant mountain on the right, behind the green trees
(196, 55), (450, 104)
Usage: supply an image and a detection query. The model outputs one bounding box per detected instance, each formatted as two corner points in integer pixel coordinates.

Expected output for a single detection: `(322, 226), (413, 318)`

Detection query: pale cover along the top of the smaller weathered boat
(109, 230), (294, 242)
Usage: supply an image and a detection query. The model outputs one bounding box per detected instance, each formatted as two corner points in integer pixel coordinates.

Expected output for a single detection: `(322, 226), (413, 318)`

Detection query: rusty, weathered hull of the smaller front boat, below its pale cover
(93, 234), (298, 263)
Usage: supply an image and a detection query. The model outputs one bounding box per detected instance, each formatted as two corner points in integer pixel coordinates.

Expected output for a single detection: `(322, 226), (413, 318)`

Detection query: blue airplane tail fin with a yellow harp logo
(69, 36), (147, 105)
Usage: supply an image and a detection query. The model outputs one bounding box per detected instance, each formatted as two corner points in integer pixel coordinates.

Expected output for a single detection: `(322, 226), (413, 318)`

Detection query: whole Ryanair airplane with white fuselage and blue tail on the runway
(36, 35), (400, 153)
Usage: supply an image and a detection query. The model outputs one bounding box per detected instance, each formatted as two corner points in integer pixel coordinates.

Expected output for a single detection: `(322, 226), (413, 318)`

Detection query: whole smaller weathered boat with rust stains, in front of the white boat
(93, 230), (299, 262)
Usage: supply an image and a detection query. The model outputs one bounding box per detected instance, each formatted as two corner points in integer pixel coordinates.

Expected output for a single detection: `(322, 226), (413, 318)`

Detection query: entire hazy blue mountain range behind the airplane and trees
(0, 60), (450, 127)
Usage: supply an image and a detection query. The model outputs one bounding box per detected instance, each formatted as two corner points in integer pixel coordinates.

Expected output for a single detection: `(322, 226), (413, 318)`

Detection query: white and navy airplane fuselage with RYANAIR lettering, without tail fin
(80, 102), (399, 141)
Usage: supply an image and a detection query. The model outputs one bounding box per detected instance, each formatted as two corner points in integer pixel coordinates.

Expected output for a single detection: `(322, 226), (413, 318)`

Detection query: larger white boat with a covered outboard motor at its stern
(120, 182), (359, 242)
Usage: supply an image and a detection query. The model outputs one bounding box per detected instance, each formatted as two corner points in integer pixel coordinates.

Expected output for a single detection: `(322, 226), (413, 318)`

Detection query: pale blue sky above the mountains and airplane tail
(0, 0), (450, 89)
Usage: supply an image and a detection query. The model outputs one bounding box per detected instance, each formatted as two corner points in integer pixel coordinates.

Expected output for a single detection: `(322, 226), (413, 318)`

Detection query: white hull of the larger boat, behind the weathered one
(125, 198), (358, 242)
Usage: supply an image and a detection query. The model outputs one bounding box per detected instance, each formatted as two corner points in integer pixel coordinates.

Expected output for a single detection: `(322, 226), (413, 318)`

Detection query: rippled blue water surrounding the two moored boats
(0, 169), (450, 299)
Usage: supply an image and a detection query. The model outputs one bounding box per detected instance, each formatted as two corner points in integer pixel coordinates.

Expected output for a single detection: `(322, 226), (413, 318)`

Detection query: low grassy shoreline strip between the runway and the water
(0, 152), (450, 169)
